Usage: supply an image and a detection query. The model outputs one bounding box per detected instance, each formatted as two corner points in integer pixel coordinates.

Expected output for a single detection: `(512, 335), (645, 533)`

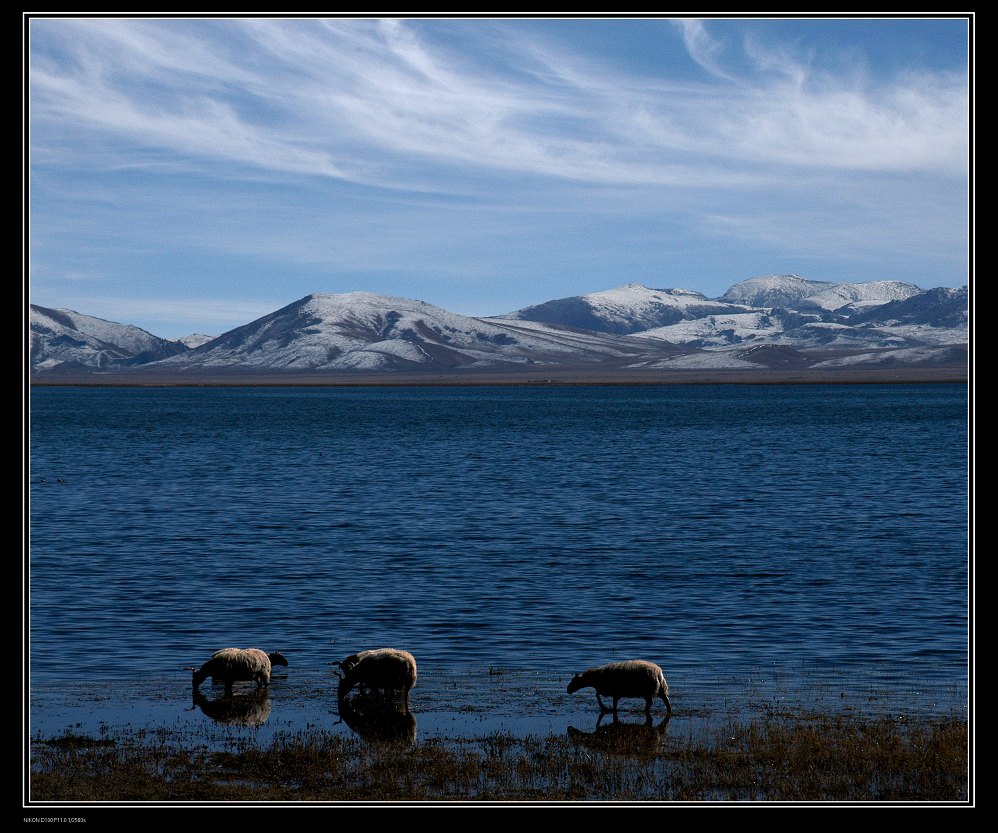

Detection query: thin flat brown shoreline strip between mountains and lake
(29, 366), (969, 387)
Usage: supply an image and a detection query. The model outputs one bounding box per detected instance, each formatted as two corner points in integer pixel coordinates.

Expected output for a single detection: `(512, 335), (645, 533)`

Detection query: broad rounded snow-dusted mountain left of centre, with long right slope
(157, 292), (681, 371)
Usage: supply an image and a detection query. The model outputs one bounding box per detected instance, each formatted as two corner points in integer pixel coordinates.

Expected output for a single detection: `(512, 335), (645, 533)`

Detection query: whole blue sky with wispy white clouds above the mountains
(27, 17), (970, 338)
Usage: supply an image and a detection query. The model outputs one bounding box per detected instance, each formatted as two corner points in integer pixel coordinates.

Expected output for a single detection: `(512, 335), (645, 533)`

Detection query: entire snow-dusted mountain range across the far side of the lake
(30, 275), (969, 375)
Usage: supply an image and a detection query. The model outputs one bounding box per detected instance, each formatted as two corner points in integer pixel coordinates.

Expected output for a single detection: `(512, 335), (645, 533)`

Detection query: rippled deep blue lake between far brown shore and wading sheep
(29, 385), (968, 728)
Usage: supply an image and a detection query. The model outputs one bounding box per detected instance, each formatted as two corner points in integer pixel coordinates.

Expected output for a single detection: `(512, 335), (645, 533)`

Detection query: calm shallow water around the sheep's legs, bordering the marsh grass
(32, 664), (967, 748)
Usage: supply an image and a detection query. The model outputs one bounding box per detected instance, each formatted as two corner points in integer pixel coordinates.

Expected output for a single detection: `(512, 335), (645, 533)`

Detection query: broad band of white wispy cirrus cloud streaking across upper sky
(32, 20), (968, 187)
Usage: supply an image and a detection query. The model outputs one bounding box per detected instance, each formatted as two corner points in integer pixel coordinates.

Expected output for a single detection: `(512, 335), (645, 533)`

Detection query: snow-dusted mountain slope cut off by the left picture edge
(29, 304), (188, 370)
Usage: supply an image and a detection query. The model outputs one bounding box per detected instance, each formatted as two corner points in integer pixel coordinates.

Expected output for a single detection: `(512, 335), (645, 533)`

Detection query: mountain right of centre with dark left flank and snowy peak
(503, 283), (743, 335)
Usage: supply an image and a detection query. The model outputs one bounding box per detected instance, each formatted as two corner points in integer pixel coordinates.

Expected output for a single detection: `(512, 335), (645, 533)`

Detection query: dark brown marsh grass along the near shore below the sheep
(30, 715), (968, 802)
